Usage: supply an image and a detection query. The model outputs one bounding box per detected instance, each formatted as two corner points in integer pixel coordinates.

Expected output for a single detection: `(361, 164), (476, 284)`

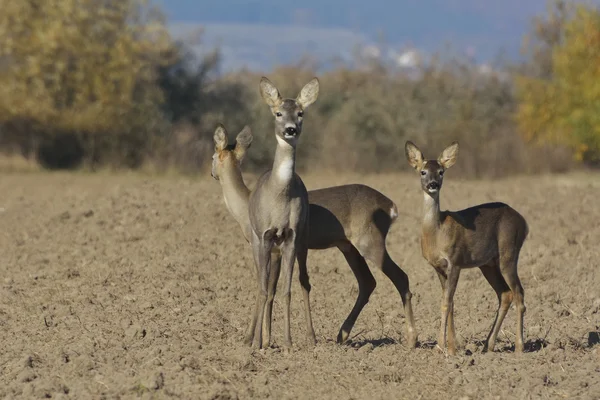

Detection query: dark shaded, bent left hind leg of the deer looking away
(337, 243), (377, 344)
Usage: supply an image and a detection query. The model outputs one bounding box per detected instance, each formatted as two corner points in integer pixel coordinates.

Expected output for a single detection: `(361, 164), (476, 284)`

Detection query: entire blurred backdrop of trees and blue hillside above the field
(0, 0), (600, 178)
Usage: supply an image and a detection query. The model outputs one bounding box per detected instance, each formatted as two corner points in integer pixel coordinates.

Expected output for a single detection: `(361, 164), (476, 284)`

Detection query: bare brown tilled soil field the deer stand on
(0, 173), (600, 399)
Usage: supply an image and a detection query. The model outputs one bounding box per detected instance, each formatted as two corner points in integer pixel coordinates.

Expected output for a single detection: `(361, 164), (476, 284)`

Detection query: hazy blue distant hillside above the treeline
(158, 0), (600, 69)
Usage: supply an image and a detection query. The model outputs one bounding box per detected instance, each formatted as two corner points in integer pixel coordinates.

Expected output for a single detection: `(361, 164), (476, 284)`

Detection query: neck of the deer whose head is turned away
(219, 161), (250, 240)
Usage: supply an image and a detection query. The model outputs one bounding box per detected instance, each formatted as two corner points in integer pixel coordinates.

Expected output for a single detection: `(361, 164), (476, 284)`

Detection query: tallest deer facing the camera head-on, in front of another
(248, 77), (319, 350)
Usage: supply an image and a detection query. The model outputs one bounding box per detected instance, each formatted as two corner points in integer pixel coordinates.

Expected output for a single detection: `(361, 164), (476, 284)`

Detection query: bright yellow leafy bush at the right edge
(515, 6), (600, 161)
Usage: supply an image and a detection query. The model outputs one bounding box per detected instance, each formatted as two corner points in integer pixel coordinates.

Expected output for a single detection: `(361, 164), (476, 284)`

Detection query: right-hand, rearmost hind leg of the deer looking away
(359, 239), (417, 348)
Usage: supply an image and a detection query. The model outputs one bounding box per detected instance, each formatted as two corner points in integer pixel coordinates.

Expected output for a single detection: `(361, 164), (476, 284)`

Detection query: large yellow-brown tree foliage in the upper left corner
(0, 0), (173, 138)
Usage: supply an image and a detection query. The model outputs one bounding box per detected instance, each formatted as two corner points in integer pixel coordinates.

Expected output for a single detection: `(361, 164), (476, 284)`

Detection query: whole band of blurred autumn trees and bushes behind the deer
(0, 0), (600, 173)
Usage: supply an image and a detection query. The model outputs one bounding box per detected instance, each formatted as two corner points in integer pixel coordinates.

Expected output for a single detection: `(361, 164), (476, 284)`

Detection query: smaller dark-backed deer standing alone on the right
(405, 141), (529, 355)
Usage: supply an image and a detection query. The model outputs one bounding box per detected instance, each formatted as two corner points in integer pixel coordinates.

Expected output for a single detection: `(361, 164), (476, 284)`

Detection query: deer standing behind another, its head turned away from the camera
(211, 125), (417, 347)
